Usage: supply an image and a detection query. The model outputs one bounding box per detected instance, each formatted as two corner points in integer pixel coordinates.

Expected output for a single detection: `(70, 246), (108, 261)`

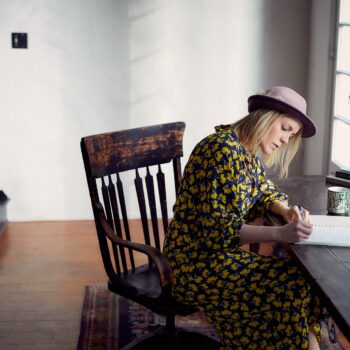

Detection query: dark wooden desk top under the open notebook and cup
(272, 176), (350, 340)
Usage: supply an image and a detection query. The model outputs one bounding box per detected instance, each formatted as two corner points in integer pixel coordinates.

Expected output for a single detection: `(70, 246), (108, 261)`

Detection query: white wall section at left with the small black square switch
(0, 0), (129, 220)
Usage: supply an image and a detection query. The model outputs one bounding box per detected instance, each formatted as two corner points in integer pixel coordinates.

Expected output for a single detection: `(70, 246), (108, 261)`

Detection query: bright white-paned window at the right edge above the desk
(331, 0), (350, 168)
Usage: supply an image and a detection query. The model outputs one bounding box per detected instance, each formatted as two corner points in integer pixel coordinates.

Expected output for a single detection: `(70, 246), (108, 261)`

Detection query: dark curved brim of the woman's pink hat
(248, 95), (317, 137)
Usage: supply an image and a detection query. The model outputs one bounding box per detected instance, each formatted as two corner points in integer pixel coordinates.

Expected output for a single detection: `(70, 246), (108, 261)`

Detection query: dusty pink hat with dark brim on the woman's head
(248, 86), (317, 137)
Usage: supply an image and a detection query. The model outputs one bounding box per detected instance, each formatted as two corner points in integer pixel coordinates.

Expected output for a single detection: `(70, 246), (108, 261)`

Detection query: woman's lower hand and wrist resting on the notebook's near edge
(276, 219), (312, 243)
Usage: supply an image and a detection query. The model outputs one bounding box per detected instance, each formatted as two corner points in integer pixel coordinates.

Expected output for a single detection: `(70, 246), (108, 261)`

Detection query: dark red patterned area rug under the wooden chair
(77, 285), (343, 350)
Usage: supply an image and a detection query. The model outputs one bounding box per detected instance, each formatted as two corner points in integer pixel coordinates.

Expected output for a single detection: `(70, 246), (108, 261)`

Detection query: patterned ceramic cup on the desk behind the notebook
(327, 186), (350, 215)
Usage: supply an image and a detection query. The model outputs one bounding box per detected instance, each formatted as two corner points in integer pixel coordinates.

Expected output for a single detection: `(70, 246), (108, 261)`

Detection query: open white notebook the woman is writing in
(297, 215), (350, 247)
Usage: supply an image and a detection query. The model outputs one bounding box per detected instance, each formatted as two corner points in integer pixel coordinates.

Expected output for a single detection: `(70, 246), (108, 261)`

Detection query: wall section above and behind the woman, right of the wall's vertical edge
(129, 0), (310, 155)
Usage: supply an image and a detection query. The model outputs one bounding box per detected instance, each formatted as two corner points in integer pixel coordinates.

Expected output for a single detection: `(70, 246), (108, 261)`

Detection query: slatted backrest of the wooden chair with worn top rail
(81, 122), (185, 278)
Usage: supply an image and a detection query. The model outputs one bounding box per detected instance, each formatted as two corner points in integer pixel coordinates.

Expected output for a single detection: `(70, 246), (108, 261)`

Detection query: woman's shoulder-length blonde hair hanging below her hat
(216, 109), (302, 177)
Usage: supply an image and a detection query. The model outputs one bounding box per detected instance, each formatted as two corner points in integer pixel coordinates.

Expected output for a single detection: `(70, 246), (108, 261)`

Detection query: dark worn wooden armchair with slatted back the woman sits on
(81, 122), (219, 350)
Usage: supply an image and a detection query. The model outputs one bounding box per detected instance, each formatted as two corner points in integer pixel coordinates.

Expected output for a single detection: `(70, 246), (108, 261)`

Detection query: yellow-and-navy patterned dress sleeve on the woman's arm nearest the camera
(198, 138), (245, 251)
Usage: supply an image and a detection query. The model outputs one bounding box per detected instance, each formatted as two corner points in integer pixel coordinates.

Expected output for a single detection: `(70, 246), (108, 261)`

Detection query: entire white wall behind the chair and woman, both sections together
(0, 0), (310, 220)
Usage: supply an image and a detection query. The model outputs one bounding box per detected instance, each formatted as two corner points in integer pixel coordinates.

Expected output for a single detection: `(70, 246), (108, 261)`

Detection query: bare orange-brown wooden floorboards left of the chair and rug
(0, 221), (350, 350)
